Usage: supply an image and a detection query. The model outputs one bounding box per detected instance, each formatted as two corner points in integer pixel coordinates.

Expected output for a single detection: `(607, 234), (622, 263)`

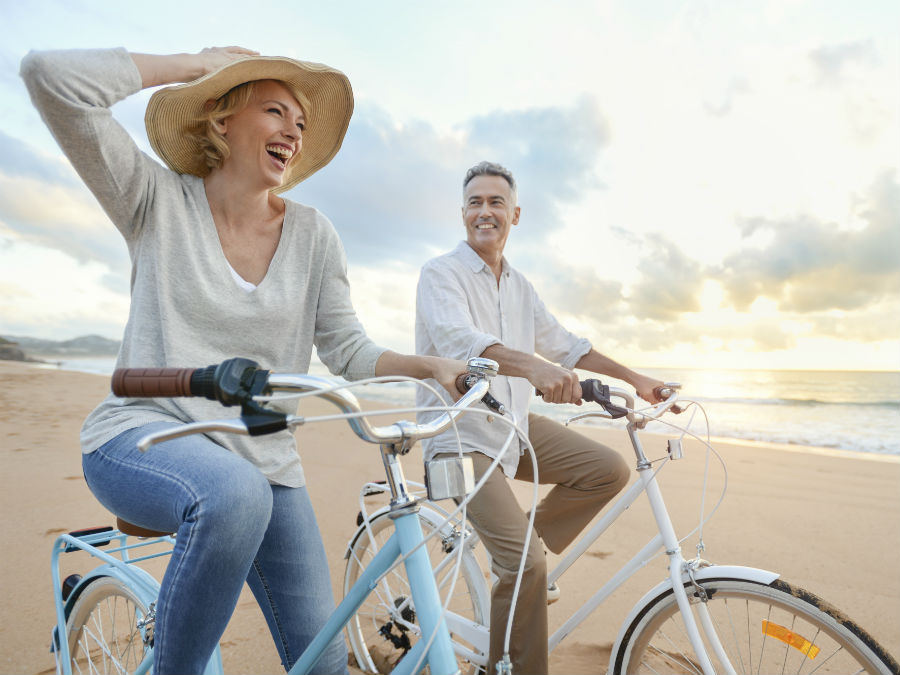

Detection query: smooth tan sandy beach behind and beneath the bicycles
(0, 361), (900, 673)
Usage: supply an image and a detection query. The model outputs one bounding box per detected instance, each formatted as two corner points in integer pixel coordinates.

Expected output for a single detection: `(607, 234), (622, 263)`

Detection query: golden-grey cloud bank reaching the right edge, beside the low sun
(714, 172), (900, 313)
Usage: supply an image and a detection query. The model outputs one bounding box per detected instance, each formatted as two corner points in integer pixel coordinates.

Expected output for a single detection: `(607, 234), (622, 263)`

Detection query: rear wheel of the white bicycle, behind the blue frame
(344, 509), (490, 673)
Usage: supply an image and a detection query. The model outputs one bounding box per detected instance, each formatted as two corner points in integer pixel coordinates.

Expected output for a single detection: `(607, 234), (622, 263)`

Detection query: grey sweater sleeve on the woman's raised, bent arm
(20, 48), (162, 240)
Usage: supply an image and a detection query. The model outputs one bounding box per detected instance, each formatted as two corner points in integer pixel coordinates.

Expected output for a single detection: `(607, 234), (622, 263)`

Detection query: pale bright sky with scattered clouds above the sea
(0, 0), (900, 370)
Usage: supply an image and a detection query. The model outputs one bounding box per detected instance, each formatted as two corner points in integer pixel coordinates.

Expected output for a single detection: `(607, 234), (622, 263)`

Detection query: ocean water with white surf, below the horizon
(45, 358), (900, 455)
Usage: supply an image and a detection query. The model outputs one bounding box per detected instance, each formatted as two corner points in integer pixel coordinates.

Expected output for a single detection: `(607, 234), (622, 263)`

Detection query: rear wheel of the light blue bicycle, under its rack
(66, 577), (149, 673)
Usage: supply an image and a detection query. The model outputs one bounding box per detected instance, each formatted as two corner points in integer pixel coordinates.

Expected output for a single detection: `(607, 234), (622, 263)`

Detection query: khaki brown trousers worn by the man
(436, 415), (630, 675)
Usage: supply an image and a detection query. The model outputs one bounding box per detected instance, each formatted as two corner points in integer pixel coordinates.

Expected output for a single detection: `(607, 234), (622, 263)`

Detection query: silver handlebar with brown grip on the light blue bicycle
(112, 358), (502, 451)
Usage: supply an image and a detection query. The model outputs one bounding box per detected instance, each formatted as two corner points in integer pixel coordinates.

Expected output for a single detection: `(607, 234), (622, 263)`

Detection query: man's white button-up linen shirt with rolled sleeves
(416, 241), (591, 477)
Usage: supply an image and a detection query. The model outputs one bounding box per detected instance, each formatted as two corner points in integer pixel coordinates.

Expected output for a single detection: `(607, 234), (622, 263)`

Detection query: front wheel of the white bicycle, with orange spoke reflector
(610, 578), (898, 675)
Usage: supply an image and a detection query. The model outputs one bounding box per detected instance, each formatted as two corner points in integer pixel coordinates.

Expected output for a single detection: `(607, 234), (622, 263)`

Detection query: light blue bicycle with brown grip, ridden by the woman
(51, 358), (497, 675)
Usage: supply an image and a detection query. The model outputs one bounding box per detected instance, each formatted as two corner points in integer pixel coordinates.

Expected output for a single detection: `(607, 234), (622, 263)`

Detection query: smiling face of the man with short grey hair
(462, 176), (519, 258)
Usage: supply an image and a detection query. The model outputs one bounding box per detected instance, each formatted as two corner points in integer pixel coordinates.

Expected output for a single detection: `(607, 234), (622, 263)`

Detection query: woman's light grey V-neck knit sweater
(21, 49), (384, 487)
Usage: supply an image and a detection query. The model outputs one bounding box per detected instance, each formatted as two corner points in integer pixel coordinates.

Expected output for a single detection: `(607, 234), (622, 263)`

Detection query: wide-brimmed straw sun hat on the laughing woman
(144, 56), (353, 192)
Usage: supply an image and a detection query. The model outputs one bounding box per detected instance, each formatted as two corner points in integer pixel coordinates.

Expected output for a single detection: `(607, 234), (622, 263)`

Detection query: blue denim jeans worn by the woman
(82, 422), (347, 674)
